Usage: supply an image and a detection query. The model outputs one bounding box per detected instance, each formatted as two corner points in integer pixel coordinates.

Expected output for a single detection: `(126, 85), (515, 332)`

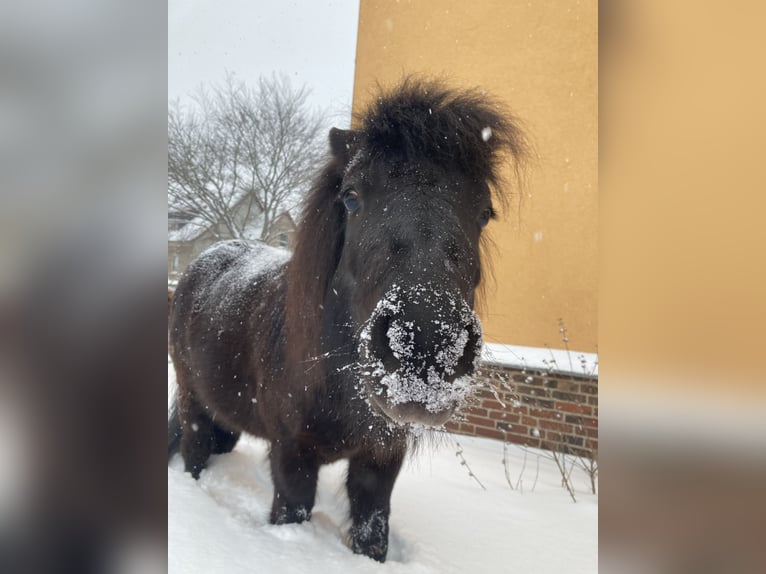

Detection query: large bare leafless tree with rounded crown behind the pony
(168, 75), (323, 239)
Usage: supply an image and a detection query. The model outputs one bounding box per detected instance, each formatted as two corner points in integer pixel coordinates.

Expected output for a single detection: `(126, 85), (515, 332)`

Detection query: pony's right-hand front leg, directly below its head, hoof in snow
(346, 448), (405, 562)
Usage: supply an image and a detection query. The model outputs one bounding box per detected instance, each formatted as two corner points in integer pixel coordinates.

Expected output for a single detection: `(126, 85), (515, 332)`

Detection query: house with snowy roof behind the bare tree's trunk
(168, 204), (296, 285)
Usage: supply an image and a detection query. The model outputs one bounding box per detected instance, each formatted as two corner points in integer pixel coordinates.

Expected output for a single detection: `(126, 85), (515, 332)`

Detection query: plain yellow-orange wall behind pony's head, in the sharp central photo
(354, 0), (598, 352)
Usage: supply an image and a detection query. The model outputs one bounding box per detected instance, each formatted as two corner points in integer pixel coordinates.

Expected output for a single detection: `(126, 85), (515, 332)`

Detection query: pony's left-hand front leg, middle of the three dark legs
(269, 441), (319, 524)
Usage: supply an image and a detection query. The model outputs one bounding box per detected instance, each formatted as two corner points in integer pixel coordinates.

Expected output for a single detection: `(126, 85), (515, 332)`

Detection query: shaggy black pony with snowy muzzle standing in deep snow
(168, 79), (526, 561)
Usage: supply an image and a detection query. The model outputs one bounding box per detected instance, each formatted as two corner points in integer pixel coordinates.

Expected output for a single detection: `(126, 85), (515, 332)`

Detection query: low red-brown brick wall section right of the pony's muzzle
(446, 365), (598, 457)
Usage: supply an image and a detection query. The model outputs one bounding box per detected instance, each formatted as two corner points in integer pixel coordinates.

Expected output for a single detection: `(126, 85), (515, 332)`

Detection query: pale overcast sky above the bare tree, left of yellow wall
(168, 0), (359, 127)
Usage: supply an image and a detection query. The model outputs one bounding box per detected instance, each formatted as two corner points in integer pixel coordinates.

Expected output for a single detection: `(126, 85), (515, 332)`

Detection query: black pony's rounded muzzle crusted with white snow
(359, 284), (482, 426)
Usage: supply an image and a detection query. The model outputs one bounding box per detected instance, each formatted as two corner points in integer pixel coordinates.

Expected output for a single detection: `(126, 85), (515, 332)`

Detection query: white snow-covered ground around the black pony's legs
(168, 368), (598, 574)
